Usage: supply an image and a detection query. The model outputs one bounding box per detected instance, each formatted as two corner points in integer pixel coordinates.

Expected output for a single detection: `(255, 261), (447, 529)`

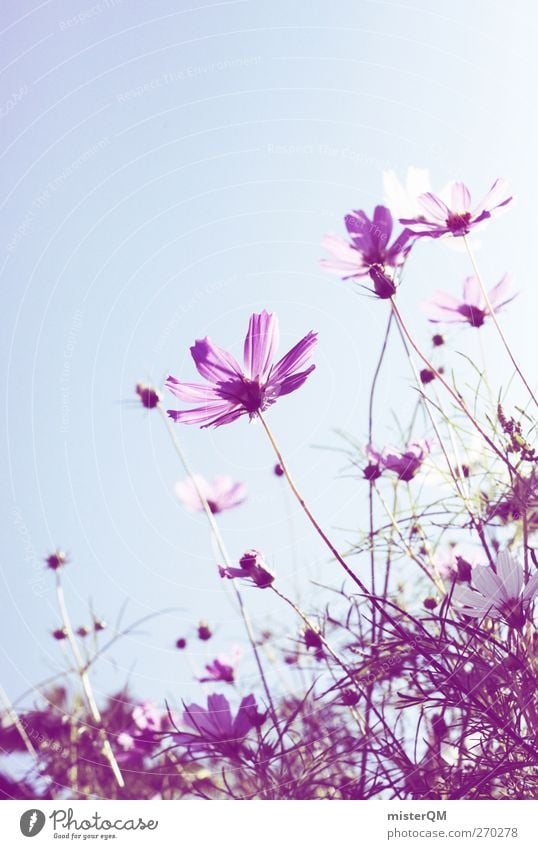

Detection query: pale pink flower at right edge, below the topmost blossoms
(422, 274), (516, 327)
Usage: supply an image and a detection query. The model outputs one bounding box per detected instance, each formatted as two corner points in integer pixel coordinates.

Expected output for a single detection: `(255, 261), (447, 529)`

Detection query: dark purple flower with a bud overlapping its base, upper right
(321, 206), (412, 298)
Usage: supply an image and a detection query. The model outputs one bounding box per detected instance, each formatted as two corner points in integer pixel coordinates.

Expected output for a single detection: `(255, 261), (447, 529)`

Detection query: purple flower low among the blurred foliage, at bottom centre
(174, 693), (263, 748)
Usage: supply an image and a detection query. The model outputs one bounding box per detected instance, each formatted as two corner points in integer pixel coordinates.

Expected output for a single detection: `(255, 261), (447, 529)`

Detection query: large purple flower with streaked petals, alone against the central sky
(165, 310), (317, 427)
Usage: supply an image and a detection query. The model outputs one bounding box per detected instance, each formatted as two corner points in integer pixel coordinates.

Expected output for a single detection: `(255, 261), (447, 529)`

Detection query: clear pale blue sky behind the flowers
(0, 0), (538, 706)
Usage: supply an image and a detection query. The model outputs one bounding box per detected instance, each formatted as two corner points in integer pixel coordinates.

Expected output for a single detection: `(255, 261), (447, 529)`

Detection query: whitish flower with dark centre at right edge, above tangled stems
(452, 551), (538, 628)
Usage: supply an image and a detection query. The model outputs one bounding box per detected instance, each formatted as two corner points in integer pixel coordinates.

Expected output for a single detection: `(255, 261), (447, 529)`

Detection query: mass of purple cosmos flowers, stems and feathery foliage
(0, 169), (538, 800)
